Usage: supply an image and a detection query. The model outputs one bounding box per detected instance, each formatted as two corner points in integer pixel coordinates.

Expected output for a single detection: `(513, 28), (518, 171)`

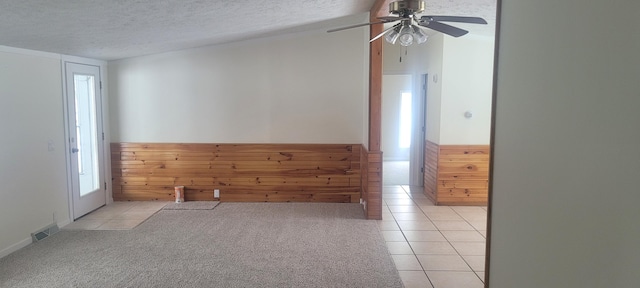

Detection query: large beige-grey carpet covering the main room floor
(0, 203), (402, 287)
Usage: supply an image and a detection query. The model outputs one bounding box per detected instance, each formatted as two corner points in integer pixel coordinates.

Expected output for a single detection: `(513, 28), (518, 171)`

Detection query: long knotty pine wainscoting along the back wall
(111, 143), (363, 203)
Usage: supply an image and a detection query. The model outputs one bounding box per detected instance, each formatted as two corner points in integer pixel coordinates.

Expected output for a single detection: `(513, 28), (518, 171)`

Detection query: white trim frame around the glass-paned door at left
(60, 55), (113, 222)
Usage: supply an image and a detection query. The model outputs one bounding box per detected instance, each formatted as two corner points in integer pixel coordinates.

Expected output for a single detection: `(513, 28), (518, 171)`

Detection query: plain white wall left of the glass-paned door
(0, 46), (69, 257)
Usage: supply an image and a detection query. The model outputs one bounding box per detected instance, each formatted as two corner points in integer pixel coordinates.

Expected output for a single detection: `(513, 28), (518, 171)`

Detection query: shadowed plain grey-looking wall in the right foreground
(489, 0), (640, 288)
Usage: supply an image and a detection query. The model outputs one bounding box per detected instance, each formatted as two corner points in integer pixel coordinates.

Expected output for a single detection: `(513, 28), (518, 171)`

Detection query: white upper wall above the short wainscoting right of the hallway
(439, 35), (494, 145)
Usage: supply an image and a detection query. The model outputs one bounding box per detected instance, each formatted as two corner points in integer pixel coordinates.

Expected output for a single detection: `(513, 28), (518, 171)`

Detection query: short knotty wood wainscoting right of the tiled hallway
(424, 141), (490, 205)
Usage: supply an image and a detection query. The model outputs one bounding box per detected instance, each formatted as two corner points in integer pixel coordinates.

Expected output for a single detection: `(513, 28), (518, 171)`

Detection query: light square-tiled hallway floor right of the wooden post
(378, 185), (487, 288)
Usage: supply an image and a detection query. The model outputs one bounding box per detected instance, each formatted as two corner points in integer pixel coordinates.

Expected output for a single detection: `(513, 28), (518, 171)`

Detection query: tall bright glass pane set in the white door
(73, 74), (100, 196)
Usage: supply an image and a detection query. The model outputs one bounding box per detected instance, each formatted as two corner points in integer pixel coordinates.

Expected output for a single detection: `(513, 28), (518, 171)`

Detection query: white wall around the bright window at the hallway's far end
(380, 75), (413, 161)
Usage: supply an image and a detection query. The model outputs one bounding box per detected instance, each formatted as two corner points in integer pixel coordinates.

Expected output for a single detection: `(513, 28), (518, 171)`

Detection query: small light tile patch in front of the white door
(62, 201), (170, 230)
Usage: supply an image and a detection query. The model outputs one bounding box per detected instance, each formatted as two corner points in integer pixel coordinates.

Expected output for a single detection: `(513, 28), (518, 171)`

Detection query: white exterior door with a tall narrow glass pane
(65, 62), (106, 219)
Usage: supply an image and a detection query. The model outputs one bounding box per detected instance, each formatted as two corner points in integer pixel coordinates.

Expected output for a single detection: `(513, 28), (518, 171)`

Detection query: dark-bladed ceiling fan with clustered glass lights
(327, 0), (487, 46)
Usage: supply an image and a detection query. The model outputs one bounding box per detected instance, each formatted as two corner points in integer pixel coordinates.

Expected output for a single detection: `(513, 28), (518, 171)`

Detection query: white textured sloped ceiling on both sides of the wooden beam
(0, 0), (495, 60)
